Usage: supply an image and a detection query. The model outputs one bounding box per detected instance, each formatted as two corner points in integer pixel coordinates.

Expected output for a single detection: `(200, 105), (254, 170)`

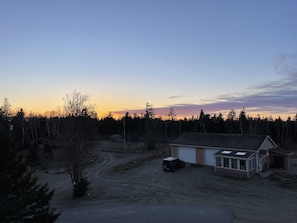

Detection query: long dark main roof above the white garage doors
(172, 132), (267, 150)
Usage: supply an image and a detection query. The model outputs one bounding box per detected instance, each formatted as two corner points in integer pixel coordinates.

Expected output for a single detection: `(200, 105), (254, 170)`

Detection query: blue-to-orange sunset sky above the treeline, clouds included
(0, 0), (297, 118)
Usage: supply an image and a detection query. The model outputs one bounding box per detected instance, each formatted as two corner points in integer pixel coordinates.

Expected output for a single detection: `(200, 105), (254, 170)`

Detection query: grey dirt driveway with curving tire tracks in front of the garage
(38, 143), (297, 222)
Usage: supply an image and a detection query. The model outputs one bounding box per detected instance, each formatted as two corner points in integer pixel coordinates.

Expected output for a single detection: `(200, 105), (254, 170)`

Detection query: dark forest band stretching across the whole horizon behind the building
(0, 99), (297, 154)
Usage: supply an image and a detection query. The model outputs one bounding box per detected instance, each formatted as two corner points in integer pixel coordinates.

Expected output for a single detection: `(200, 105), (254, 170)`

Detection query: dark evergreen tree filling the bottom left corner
(0, 129), (60, 223)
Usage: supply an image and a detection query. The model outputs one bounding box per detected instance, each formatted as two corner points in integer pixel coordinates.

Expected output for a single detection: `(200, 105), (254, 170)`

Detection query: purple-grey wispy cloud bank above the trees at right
(115, 54), (297, 116)
